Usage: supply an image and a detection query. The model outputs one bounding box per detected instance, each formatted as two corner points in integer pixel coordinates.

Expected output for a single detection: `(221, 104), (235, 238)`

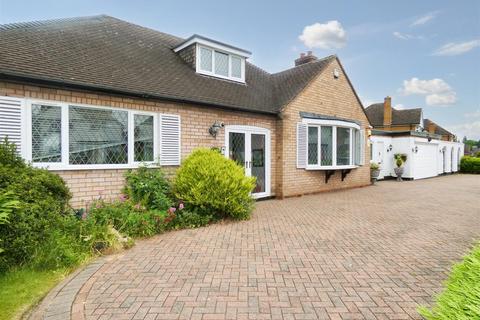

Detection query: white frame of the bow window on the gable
(302, 118), (361, 170)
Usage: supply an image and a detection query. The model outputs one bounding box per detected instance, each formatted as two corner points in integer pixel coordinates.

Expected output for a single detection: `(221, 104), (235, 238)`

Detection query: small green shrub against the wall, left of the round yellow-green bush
(123, 167), (173, 210)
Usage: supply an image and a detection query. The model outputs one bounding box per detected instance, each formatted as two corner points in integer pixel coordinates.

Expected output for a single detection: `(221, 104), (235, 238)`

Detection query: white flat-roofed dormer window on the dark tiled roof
(174, 35), (250, 83)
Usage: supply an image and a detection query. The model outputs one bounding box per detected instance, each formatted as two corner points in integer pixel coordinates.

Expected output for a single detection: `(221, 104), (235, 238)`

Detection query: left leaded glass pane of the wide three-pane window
(32, 105), (62, 162)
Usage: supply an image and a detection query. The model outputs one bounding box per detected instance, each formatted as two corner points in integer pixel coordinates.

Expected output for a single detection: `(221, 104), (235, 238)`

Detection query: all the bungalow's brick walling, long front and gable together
(0, 60), (370, 207)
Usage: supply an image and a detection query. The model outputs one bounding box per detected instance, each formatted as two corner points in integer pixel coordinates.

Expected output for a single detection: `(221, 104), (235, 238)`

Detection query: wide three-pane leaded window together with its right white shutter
(25, 102), (181, 170)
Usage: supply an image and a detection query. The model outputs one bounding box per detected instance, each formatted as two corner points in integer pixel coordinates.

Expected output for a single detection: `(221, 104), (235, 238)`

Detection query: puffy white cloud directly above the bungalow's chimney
(298, 20), (347, 49)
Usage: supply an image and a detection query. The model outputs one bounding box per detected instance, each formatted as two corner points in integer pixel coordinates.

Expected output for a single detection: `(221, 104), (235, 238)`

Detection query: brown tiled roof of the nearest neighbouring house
(365, 103), (422, 127)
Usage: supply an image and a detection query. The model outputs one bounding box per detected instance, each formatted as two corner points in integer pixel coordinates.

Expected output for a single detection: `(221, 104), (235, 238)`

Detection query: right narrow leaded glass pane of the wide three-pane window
(133, 114), (153, 161)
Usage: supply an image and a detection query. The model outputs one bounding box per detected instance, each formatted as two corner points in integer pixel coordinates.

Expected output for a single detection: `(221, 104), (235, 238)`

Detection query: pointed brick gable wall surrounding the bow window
(277, 60), (370, 197)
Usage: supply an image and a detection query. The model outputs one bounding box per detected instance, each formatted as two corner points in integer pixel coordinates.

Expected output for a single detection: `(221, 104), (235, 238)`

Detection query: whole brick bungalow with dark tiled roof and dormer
(0, 15), (370, 207)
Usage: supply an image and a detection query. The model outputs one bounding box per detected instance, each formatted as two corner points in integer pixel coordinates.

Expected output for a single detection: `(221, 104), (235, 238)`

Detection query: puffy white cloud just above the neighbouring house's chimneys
(400, 78), (457, 106)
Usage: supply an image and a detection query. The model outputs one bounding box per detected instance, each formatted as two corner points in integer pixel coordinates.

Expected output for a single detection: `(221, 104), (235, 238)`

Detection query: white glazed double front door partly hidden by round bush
(225, 126), (270, 198)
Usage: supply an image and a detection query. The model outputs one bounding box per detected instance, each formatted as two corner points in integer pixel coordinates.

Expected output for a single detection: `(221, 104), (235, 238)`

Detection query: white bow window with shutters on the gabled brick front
(297, 119), (364, 170)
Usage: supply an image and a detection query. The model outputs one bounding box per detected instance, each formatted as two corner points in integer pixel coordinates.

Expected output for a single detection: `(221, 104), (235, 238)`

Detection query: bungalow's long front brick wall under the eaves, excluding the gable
(0, 82), (277, 207)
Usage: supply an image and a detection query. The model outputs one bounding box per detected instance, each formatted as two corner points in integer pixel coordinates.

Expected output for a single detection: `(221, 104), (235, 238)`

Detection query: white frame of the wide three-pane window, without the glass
(22, 99), (174, 171)
